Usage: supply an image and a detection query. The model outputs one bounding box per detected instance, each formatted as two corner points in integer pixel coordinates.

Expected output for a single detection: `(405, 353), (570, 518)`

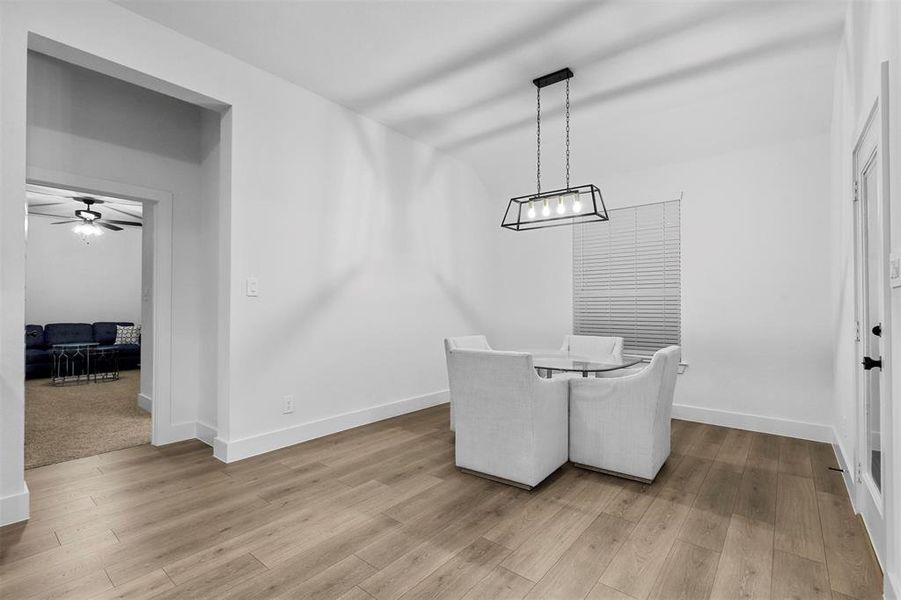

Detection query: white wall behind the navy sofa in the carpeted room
(25, 215), (141, 325)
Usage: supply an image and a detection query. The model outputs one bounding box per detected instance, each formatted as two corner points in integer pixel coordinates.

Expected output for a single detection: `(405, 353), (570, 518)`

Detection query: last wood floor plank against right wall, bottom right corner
(817, 492), (883, 600)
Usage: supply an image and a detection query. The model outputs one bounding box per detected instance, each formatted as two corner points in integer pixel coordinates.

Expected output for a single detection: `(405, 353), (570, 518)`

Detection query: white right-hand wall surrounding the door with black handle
(830, 2), (901, 598)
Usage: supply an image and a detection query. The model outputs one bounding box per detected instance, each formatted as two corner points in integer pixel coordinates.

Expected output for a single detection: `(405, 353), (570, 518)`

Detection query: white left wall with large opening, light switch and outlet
(0, 2), (494, 518)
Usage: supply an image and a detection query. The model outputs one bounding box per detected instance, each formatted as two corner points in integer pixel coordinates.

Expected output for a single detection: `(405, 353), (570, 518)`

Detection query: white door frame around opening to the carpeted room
(26, 167), (178, 446)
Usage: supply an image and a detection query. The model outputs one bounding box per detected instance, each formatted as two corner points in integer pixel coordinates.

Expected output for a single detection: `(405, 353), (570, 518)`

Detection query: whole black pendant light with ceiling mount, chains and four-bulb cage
(501, 68), (609, 231)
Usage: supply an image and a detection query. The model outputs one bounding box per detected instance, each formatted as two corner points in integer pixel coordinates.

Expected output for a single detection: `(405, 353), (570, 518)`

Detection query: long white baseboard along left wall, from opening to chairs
(213, 390), (449, 463)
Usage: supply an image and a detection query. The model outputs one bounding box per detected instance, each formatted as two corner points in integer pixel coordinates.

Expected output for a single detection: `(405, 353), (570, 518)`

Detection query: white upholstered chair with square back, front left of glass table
(449, 349), (569, 489)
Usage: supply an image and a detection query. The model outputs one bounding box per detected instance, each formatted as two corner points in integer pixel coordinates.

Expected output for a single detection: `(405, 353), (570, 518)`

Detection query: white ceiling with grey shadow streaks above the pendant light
(118, 0), (845, 189)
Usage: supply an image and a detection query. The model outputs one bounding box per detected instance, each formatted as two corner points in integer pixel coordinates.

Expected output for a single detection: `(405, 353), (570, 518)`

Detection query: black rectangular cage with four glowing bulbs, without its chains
(501, 184), (609, 231)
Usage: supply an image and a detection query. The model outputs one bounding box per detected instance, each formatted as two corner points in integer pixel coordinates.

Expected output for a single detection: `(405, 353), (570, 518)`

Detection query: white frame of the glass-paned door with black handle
(851, 62), (894, 569)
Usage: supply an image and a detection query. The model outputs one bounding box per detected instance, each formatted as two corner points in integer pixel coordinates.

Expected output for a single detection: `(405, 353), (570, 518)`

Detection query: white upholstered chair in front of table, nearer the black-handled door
(568, 346), (681, 483)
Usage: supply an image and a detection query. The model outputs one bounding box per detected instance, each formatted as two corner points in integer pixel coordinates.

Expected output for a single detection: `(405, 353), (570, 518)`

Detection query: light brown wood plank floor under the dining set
(0, 406), (882, 600)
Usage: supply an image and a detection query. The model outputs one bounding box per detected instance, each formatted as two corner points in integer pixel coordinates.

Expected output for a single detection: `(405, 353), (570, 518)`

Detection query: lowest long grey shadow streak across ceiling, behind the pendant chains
(440, 25), (842, 151)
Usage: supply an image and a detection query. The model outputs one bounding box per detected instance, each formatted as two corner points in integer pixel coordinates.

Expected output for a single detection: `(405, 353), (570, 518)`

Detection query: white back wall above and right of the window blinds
(604, 135), (832, 434)
